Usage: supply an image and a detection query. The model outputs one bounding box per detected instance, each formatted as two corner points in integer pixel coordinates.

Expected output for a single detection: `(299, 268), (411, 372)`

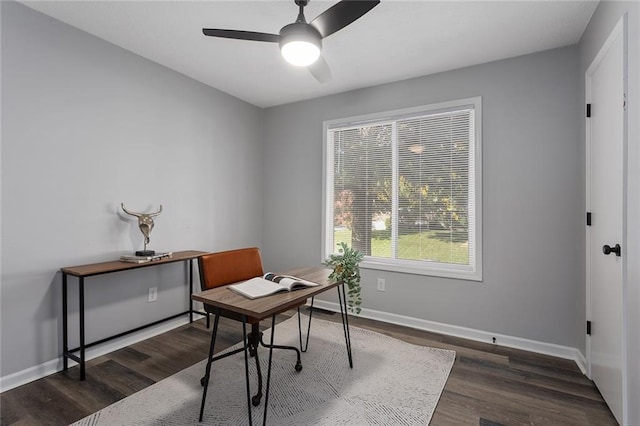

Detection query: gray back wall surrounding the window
(262, 46), (584, 347)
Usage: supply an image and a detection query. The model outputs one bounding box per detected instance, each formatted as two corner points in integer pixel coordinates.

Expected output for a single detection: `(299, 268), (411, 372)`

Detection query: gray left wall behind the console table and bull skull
(0, 1), (262, 376)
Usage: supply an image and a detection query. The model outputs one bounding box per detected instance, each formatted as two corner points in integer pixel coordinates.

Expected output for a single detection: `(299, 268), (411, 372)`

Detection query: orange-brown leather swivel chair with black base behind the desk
(198, 247), (302, 406)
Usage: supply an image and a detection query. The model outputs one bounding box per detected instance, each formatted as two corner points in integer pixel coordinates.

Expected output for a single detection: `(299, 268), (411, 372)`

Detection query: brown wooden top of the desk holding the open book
(191, 267), (338, 320)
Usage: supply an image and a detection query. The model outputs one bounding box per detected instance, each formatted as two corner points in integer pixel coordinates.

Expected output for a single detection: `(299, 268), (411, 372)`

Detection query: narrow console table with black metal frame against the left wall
(60, 250), (206, 380)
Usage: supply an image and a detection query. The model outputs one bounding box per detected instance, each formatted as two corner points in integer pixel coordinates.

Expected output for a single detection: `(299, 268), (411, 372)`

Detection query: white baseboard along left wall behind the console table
(0, 315), (189, 392)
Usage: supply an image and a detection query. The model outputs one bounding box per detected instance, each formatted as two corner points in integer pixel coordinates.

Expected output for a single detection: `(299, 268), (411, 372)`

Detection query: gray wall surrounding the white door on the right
(577, 1), (640, 425)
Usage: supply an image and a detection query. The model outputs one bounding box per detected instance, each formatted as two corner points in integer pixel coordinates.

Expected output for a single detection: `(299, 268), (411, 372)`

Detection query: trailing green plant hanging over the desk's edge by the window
(326, 242), (364, 315)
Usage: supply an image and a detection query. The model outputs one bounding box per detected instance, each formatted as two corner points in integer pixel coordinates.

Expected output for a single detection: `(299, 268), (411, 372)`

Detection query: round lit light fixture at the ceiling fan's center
(280, 22), (322, 67)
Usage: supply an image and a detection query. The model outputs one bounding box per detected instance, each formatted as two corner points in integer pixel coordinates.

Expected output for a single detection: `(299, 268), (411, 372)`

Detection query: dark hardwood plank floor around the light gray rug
(0, 311), (617, 426)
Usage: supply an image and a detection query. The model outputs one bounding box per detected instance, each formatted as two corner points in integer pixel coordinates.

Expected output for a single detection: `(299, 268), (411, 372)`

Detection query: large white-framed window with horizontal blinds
(322, 97), (482, 280)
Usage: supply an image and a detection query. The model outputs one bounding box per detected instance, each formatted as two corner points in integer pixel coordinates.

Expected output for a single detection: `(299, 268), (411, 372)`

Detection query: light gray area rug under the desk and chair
(74, 316), (455, 426)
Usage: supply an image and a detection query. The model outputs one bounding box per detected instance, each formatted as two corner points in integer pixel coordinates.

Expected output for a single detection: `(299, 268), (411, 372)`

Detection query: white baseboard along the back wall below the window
(313, 300), (587, 374)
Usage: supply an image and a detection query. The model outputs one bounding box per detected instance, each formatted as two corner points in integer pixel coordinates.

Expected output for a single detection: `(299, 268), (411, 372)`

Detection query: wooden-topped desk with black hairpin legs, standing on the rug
(191, 267), (353, 425)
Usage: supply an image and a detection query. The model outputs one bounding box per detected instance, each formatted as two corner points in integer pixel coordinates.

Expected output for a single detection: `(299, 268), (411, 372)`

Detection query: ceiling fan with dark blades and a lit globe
(202, 0), (380, 83)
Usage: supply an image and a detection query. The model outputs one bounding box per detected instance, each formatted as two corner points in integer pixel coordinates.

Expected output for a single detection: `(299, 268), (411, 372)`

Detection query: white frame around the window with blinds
(321, 96), (483, 281)
